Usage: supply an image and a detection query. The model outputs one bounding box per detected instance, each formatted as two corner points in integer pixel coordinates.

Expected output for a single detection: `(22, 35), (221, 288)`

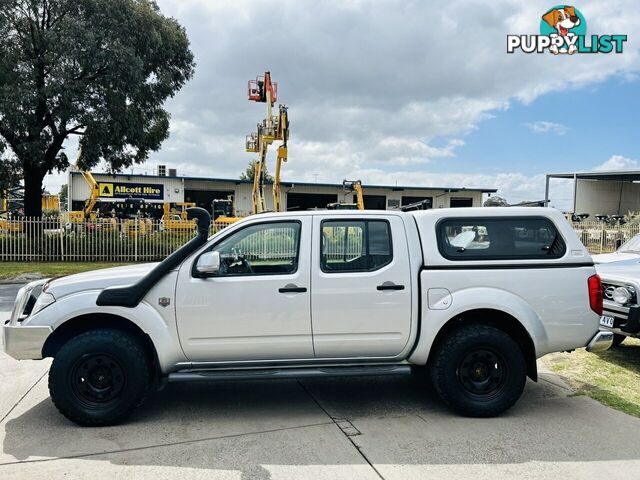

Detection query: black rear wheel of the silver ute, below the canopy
(431, 325), (527, 417)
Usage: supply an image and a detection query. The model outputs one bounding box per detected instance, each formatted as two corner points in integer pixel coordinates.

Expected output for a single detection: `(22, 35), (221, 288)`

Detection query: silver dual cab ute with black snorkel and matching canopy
(4, 208), (613, 425)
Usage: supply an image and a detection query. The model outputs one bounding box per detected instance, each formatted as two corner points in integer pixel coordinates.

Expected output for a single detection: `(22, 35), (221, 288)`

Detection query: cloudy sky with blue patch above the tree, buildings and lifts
(48, 0), (640, 207)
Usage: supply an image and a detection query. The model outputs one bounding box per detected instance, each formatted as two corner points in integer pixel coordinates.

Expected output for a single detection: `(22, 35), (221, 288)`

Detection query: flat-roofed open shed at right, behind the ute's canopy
(545, 170), (640, 218)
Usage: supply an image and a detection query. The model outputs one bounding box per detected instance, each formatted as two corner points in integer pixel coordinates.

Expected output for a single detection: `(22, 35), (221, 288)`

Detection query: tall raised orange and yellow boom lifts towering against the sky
(245, 72), (289, 213)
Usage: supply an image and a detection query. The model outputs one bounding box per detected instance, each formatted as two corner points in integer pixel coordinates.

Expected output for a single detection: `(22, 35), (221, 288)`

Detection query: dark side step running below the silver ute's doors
(168, 365), (411, 382)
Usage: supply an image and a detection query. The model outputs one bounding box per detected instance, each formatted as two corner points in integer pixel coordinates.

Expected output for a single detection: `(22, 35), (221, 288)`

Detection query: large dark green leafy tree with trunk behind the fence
(0, 0), (195, 216)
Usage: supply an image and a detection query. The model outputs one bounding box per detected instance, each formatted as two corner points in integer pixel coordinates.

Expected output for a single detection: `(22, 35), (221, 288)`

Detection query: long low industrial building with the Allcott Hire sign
(68, 169), (496, 216)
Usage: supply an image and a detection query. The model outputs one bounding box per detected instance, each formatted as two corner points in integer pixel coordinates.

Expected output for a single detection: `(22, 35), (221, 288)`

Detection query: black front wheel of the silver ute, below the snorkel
(49, 329), (152, 426)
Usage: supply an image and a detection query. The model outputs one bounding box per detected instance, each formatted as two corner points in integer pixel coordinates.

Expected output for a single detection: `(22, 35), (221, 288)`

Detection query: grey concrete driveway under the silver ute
(0, 289), (640, 480)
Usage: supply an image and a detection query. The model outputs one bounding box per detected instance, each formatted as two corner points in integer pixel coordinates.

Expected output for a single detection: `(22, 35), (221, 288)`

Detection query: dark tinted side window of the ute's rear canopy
(436, 217), (566, 260)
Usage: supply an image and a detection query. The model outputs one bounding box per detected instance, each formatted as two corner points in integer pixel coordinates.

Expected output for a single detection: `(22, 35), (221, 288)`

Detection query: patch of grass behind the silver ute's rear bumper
(542, 338), (640, 417)
